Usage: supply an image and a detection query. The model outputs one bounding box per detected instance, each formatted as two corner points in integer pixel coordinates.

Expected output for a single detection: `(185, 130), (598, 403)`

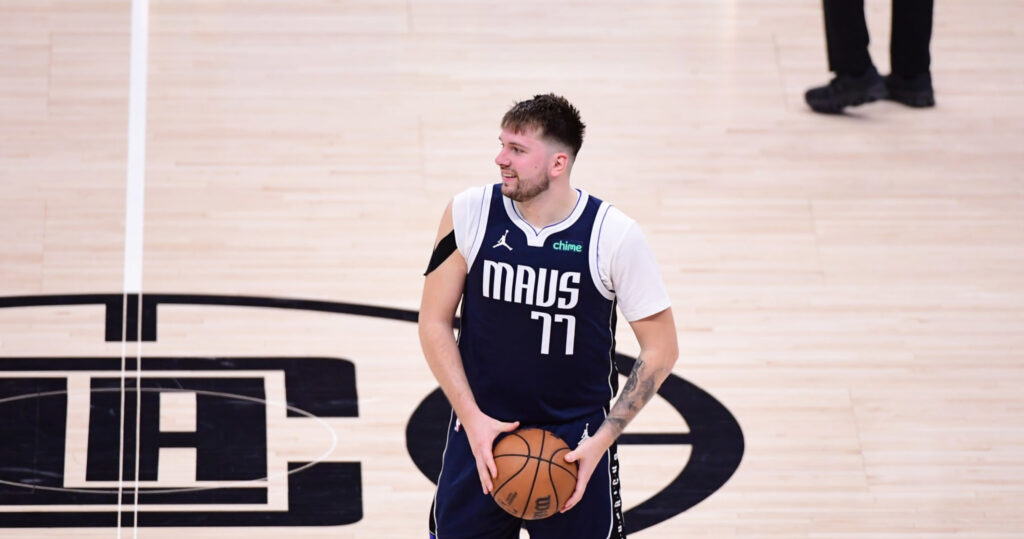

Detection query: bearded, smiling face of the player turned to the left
(495, 129), (551, 202)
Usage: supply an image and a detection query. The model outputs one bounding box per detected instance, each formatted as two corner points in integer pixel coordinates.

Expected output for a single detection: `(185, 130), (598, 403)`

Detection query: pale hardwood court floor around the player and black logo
(0, 0), (1024, 539)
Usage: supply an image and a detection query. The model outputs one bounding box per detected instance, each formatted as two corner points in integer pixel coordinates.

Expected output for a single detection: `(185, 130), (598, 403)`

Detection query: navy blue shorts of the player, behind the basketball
(430, 410), (626, 539)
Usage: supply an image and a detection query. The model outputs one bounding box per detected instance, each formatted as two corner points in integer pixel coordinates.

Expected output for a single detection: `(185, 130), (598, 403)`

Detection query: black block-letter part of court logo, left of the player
(0, 358), (362, 527)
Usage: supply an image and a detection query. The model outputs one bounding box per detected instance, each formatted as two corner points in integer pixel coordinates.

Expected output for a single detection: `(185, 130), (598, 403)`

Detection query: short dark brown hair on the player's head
(502, 93), (587, 159)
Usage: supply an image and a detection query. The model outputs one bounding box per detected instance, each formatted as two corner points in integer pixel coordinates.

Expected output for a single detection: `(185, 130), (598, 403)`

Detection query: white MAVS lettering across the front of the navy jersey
(482, 260), (581, 309)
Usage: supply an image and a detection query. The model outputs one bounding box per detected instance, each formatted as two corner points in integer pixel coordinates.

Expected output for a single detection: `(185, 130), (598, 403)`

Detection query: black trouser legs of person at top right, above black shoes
(822, 0), (934, 77)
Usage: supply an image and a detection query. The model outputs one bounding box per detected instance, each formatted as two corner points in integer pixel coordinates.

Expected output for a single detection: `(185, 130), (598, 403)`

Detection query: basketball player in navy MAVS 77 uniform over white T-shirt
(419, 94), (678, 539)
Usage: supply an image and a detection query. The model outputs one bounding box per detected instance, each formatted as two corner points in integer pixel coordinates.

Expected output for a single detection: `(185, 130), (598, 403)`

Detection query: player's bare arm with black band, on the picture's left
(419, 198), (519, 494)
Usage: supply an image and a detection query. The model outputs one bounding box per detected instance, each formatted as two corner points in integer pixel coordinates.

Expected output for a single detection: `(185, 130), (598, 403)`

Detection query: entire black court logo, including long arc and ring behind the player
(0, 294), (743, 532)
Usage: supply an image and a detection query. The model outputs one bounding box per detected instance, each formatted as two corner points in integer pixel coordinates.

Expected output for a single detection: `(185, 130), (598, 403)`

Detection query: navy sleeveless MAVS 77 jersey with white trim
(459, 183), (618, 423)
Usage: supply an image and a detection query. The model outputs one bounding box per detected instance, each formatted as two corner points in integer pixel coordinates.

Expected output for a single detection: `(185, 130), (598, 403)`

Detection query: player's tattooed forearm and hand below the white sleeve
(561, 307), (679, 512)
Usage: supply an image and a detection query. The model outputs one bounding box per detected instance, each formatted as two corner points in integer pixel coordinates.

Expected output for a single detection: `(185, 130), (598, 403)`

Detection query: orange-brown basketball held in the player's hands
(490, 428), (578, 521)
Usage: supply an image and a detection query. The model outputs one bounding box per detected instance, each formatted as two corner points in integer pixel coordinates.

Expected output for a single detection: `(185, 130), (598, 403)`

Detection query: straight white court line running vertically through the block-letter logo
(118, 0), (150, 539)
